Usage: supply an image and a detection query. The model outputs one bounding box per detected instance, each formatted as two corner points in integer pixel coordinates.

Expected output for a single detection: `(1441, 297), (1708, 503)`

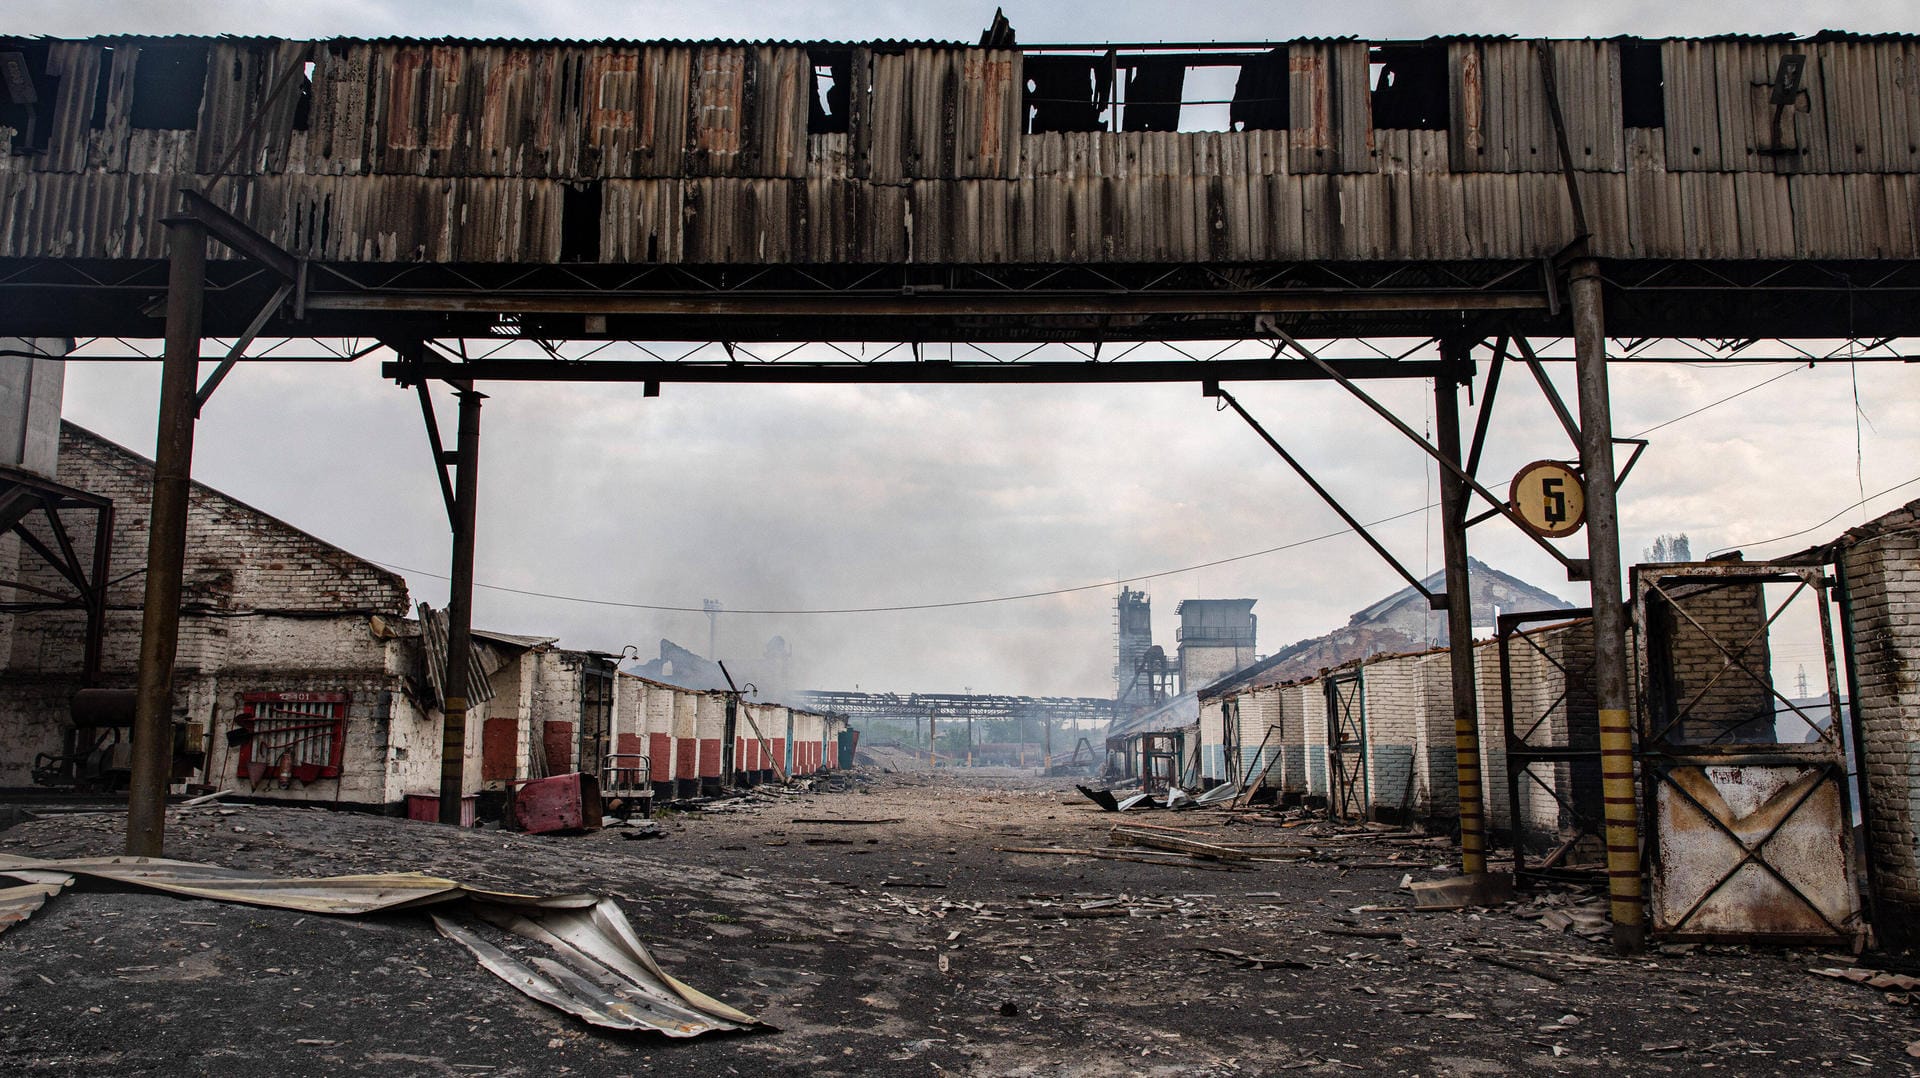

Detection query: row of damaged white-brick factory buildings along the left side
(0, 342), (845, 822)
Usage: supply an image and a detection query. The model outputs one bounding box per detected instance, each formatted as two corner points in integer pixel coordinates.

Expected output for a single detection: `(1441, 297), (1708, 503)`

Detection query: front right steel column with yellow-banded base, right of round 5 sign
(1569, 259), (1645, 953)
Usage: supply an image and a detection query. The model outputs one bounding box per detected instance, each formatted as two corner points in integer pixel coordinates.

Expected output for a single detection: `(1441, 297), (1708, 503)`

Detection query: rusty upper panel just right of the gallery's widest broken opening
(1286, 40), (1373, 173)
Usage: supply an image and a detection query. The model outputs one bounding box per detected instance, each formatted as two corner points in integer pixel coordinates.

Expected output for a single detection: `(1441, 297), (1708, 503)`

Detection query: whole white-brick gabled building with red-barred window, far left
(0, 423), (451, 805)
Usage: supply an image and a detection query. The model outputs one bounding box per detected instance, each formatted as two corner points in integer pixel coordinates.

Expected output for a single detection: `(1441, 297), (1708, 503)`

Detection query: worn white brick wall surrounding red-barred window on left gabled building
(0, 423), (418, 801)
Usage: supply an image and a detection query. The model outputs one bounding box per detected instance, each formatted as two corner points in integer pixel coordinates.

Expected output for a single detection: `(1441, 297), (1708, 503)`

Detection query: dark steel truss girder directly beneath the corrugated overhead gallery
(11, 247), (1920, 342)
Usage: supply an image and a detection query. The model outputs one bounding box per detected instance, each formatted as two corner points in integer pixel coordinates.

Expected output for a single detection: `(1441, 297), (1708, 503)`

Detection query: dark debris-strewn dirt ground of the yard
(0, 772), (1920, 1078)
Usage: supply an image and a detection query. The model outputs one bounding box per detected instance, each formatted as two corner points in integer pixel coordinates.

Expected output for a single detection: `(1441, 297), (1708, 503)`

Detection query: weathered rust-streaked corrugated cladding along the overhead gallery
(0, 38), (1920, 263)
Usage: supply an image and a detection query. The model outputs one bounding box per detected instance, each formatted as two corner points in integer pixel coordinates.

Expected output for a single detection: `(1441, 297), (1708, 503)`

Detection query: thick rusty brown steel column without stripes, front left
(127, 217), (207, 857)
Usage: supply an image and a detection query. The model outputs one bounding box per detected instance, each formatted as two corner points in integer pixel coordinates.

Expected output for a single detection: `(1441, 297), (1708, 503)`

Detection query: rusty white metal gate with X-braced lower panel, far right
(1634, 563), (1864, 943)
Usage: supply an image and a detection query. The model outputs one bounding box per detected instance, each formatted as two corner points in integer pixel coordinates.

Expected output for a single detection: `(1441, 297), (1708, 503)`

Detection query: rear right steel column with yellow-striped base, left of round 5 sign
(1434, 340), (1486, 878)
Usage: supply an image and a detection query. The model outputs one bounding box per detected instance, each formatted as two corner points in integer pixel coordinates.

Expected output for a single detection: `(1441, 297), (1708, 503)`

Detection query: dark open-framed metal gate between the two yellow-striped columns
(1494, 607), (1605, 884)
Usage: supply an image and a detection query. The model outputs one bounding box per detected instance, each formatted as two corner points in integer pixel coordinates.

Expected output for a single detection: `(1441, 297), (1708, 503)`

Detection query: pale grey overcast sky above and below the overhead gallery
(15, 0), (1920, 696)
